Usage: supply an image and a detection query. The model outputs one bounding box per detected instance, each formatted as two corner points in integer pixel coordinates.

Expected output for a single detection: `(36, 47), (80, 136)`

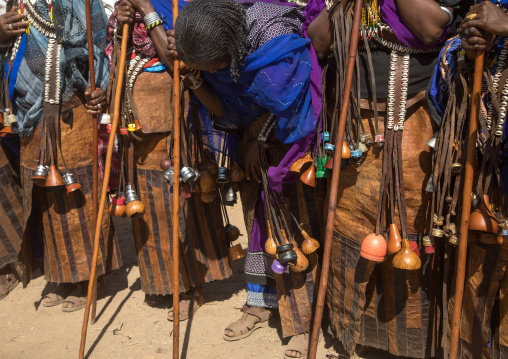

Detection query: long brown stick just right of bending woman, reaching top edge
(309, 0), (363, 359)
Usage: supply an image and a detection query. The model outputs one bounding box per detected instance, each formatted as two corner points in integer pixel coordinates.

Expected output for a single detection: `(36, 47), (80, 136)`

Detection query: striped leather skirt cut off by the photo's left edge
(0, 140), (24, 269)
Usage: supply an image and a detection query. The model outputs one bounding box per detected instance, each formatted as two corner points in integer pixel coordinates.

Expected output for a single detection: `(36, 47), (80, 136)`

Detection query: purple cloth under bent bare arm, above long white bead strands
(379, 0), (449, 50)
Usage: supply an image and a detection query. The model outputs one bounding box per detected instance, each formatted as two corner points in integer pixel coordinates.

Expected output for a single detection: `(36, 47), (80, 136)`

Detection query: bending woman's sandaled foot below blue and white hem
(223, 305), (274, 342)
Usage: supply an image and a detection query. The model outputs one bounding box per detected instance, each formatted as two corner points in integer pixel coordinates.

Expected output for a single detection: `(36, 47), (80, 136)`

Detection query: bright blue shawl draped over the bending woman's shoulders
(204, 34), (317, 143)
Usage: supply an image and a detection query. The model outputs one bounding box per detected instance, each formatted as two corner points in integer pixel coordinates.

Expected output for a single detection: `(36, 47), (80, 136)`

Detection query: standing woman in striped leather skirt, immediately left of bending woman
(106, 0), (232, 320)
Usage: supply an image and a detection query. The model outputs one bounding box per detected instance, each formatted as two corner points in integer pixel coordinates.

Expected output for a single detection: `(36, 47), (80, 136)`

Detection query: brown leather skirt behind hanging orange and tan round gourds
(327, 98), (443, 358)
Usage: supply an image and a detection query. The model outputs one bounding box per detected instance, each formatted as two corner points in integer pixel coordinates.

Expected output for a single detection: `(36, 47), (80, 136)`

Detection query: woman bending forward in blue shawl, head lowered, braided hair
(169, 0), (324, 358)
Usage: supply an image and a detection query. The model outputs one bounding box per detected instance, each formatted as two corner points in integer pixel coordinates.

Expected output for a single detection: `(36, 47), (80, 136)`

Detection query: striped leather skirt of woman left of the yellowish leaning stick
(21, 105), (122, 283)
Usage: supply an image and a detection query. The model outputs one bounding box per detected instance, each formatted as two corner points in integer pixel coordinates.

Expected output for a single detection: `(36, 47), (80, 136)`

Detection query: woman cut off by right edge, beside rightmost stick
(429, 0), (508, 358)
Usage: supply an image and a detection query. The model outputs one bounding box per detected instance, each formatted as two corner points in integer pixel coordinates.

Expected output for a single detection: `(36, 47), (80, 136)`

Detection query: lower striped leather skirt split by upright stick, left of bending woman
(133, 133), (232, 295)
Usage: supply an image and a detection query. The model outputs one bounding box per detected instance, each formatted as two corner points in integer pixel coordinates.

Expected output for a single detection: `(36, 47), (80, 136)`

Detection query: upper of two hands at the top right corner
(457, 1), (508, 36)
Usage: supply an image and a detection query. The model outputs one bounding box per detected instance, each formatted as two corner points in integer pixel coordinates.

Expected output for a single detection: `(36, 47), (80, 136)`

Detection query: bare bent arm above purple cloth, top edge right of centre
(395, 0), (449, 45)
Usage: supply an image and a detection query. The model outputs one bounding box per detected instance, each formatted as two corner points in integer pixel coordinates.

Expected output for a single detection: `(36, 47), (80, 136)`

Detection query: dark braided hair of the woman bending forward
(175, 0), (247, 78)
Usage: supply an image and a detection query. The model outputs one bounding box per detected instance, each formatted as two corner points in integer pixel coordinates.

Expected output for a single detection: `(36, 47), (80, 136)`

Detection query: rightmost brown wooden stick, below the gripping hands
(449, 53), (484, 359)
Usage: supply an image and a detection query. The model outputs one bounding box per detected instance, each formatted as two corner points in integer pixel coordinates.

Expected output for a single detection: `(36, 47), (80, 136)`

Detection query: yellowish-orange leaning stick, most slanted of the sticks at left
(79, 24), (129, 359)
